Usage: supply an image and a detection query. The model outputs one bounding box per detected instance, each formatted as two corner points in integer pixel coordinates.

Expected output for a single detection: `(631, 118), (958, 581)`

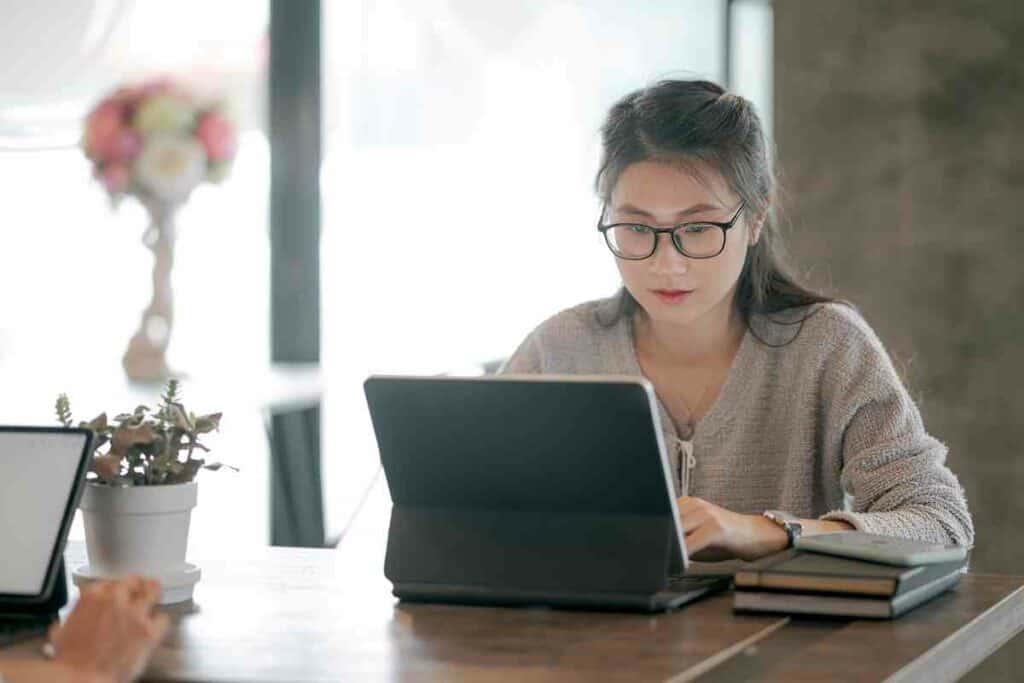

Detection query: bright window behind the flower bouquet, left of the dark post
(0, 0), (269, 543)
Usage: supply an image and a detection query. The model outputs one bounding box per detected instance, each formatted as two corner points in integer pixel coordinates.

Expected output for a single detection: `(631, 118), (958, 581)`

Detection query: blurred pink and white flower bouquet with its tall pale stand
(82, 79), (237, 380)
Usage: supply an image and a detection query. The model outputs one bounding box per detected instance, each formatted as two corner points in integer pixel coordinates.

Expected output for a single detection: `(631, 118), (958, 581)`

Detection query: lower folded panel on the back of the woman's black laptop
(384, 505), (669, 594)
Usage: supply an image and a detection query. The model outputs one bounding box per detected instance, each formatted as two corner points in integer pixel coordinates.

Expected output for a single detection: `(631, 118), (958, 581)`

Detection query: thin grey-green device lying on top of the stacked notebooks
(796, 531), (968, 566)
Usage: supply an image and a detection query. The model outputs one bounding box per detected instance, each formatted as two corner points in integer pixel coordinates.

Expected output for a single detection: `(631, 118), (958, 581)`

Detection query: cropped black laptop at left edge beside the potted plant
(0, 426), (92, 646)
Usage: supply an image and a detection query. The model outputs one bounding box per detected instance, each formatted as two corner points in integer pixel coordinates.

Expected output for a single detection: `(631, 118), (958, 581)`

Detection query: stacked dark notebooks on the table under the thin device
(734, 549), (968, 618)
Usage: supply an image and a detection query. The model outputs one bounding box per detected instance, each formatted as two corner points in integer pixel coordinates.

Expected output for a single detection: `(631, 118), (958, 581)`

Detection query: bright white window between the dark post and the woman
(322, 0), (745, 540)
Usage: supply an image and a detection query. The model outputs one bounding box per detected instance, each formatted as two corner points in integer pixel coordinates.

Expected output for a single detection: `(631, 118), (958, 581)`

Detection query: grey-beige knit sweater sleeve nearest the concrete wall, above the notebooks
(821, 313), (974, 547)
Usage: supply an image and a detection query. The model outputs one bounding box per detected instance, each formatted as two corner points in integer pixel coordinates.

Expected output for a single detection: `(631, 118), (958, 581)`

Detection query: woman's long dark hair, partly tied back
(595, 80), (846, 346)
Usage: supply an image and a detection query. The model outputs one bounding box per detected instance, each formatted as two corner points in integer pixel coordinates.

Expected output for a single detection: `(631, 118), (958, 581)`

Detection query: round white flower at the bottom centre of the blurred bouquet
(135, 135), (206, 204)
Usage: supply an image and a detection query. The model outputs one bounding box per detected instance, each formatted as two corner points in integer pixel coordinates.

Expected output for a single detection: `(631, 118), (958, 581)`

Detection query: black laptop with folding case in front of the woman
(364, 375), (730, 611)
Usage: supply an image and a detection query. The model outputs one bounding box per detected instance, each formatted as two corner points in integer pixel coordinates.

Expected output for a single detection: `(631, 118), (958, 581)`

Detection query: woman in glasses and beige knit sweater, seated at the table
(503, 81), (974, 560)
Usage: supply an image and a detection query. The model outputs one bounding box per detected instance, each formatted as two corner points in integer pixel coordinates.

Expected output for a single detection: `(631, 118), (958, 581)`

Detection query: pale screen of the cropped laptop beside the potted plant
(0, 428), (88, 596)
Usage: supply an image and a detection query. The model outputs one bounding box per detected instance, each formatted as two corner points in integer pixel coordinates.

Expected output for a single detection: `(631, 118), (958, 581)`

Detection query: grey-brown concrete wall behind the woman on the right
(774, 0), (1024, 681)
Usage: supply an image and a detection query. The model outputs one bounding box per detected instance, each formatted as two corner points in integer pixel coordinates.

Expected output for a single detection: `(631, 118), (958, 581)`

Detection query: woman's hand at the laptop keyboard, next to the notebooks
(679, 496), (790, 562)
